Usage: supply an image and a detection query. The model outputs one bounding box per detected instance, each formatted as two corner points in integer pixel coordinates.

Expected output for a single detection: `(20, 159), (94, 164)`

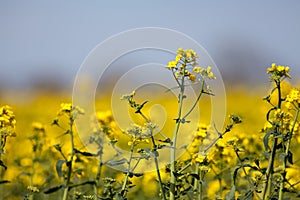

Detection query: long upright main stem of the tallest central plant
(170, 76), (184, 200)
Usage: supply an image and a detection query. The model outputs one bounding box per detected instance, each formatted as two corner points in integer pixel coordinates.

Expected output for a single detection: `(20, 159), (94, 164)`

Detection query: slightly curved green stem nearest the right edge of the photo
(279, 109), (299, 200)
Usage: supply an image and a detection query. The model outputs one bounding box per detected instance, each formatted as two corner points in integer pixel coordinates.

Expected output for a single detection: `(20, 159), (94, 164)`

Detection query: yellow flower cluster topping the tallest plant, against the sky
(166, 48), (216, 82)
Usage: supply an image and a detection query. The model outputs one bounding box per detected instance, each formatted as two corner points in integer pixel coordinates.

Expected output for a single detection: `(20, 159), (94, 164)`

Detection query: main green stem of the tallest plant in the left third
(62, 116), (75, 200)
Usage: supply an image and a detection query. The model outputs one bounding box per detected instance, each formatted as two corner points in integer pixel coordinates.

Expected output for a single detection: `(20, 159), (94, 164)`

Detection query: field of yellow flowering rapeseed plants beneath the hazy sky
(0, 52), (300, 200)
